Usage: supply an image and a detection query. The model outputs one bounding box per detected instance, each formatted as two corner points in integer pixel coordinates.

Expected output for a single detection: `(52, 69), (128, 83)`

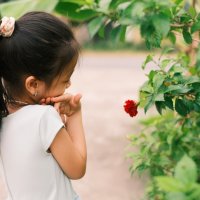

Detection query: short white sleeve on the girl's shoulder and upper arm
(39, 106), (64, 151)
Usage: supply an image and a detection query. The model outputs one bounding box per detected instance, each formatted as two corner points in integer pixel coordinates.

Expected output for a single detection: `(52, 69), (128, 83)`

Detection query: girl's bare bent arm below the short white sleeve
(50, 96), (87, 179)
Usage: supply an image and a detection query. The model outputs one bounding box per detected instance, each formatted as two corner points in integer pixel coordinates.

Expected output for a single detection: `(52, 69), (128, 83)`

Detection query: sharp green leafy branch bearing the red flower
(140, 50), (200, 116)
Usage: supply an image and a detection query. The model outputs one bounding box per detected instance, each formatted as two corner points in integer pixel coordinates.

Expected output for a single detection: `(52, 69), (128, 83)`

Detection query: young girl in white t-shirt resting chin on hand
(0, 12), (87, 200)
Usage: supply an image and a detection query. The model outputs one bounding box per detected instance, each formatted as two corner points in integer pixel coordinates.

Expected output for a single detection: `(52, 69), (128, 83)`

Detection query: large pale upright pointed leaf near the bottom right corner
(175, 155), (197, 184)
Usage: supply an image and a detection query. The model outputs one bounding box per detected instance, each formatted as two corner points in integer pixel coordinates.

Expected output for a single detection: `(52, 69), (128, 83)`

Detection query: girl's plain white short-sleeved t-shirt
(0, 105), (79, 200)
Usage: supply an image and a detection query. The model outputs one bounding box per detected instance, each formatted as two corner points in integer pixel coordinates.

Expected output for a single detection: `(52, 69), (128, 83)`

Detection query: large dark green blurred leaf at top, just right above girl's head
(55, 2), (99, 22)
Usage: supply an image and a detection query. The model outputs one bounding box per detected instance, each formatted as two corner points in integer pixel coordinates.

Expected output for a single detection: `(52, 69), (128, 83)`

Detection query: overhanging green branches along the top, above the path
(56, 0), (200, 49)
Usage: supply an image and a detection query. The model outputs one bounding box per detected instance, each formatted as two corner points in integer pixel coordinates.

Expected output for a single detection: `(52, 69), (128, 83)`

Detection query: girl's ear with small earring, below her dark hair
(25, 76), (40, 96)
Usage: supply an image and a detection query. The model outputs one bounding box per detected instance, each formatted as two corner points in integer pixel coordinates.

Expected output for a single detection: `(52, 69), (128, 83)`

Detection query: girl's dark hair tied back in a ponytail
(0, 12), (79, 124)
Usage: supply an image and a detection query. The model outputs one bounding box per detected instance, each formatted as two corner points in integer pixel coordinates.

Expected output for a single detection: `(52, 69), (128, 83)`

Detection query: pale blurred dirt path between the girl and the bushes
(71, 53), (148, 200)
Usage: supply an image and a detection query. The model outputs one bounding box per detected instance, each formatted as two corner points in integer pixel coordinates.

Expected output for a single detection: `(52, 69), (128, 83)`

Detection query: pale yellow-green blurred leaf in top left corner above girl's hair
(0, 0), (58, 18)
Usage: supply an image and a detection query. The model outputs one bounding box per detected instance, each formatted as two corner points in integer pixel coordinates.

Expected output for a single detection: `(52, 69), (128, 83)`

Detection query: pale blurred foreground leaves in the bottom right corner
(155, 155), (200, 200)
